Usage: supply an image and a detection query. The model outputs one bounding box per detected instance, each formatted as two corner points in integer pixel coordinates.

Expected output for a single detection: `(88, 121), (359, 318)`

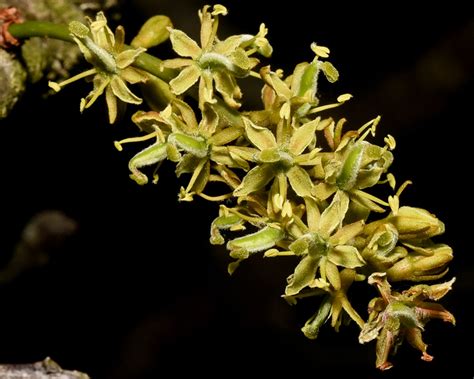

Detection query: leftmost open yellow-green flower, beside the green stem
(49, 12), (147, 123)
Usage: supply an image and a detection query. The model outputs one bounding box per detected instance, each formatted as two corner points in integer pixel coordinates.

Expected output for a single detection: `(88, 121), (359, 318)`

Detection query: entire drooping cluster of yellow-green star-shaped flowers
(46, 5), (454, 369)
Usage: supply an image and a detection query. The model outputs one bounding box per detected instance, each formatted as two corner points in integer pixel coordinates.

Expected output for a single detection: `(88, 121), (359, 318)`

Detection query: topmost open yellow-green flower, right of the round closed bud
(164, 5), (272, 109)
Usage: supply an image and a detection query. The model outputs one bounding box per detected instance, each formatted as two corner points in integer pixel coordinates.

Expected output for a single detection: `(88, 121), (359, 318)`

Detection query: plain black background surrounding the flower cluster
(0, 0), (474, 379)
